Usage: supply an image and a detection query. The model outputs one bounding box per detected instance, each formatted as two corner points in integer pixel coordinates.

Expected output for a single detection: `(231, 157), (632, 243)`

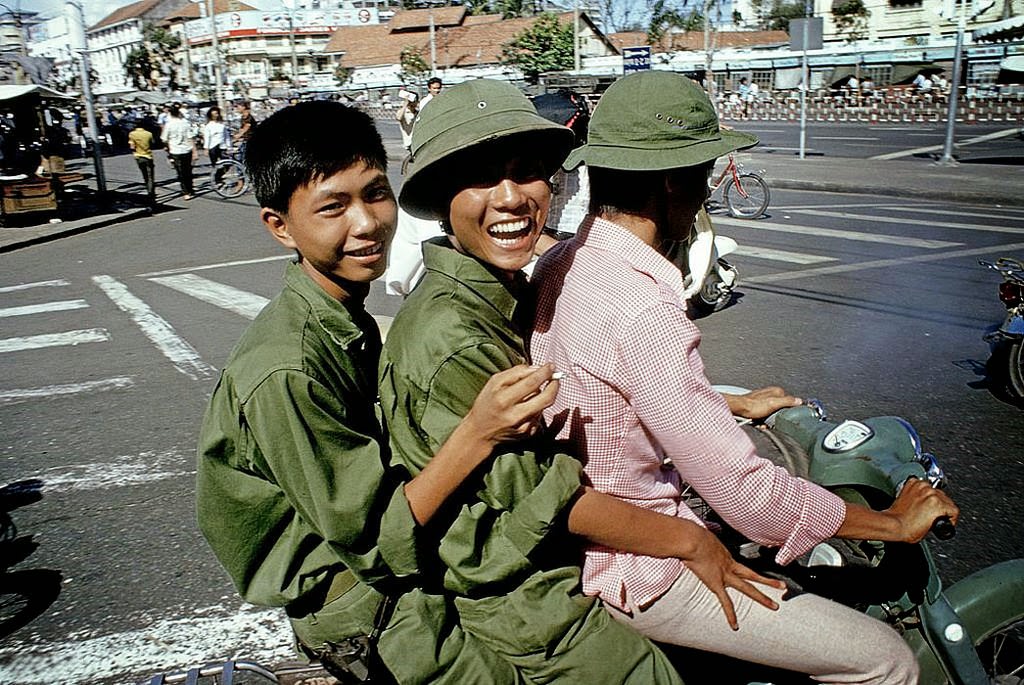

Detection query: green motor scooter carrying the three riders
(680, 388), (1024, 685)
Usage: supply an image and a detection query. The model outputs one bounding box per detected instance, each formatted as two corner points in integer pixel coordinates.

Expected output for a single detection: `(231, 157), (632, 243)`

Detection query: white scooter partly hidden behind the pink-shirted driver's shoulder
(674, 208), (739, 317)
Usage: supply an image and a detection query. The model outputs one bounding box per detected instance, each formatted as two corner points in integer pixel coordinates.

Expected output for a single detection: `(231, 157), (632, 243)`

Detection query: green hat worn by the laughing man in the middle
(398, 79), (574, 220)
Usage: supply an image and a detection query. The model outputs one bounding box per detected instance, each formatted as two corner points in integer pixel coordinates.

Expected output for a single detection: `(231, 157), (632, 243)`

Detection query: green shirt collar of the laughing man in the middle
(423, 236), (526, 320)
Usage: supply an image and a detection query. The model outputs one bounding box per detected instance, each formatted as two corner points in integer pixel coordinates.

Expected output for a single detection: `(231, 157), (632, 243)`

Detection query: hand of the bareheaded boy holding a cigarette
(463, 363), (558, 444)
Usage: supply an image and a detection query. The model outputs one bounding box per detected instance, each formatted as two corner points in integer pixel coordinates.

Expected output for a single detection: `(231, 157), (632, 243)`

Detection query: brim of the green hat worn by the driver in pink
(562, 130), (758, 171)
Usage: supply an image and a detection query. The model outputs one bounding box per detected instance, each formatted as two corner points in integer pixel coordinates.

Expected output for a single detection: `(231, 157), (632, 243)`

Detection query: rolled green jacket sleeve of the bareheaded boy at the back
(244, 371), (417, 584)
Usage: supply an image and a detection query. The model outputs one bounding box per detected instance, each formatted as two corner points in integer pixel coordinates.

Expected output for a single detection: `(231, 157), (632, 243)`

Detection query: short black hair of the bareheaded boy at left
(246, 100), (387, 212)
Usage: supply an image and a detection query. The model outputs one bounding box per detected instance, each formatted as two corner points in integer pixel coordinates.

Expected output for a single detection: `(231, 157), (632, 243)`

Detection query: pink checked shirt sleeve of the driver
(621, 302), (846, 563)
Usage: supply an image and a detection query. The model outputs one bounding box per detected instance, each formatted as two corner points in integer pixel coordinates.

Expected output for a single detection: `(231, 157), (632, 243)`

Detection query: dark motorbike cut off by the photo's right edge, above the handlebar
(978, 257), (1024, 402)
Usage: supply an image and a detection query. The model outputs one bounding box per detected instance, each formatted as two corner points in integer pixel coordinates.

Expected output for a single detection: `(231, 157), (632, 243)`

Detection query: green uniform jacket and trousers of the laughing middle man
(380, 238), (679, 683)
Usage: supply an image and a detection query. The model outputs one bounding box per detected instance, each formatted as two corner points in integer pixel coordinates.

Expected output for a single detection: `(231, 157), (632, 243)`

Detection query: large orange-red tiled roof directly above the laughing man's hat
(324, 10), (589, 69)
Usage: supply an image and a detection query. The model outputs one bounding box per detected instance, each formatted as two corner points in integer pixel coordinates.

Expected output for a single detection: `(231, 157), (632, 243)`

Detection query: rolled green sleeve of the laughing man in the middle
(395, 344), (581, 594)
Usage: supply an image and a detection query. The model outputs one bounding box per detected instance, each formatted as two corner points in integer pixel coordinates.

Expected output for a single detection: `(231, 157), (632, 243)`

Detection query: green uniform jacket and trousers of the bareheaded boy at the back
(197, 264), (516, 684)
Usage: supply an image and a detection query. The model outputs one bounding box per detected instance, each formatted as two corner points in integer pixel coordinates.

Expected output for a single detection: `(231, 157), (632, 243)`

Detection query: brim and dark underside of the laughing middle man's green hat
(398, 122), (575, 221)
